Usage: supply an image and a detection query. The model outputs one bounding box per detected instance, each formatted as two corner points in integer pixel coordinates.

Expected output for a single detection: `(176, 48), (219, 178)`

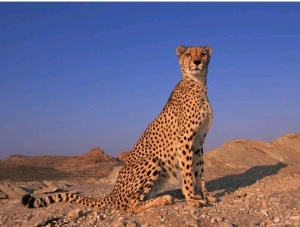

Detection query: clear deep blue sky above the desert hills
(0, 2), (300, 158)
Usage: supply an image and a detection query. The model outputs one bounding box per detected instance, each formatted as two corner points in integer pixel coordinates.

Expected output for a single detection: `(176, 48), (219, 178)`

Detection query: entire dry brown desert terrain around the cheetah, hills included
(0, 134), (300, 227)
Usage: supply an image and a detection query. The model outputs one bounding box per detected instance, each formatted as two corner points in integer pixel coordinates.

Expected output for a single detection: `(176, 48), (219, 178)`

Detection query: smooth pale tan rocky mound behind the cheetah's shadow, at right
(204, 133), (300, 168)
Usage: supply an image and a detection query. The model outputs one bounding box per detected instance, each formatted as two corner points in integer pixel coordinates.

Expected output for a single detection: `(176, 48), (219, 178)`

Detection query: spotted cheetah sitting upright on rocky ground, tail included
(21, 46), (216, 213)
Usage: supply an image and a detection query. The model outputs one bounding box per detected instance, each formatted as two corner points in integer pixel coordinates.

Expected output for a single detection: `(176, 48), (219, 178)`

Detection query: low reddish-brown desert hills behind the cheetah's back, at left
(0, 147), (121, 182)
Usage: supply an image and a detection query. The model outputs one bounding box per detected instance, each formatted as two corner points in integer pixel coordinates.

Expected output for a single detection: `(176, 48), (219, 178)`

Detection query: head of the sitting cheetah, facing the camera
(176, 46), (212, 81)
